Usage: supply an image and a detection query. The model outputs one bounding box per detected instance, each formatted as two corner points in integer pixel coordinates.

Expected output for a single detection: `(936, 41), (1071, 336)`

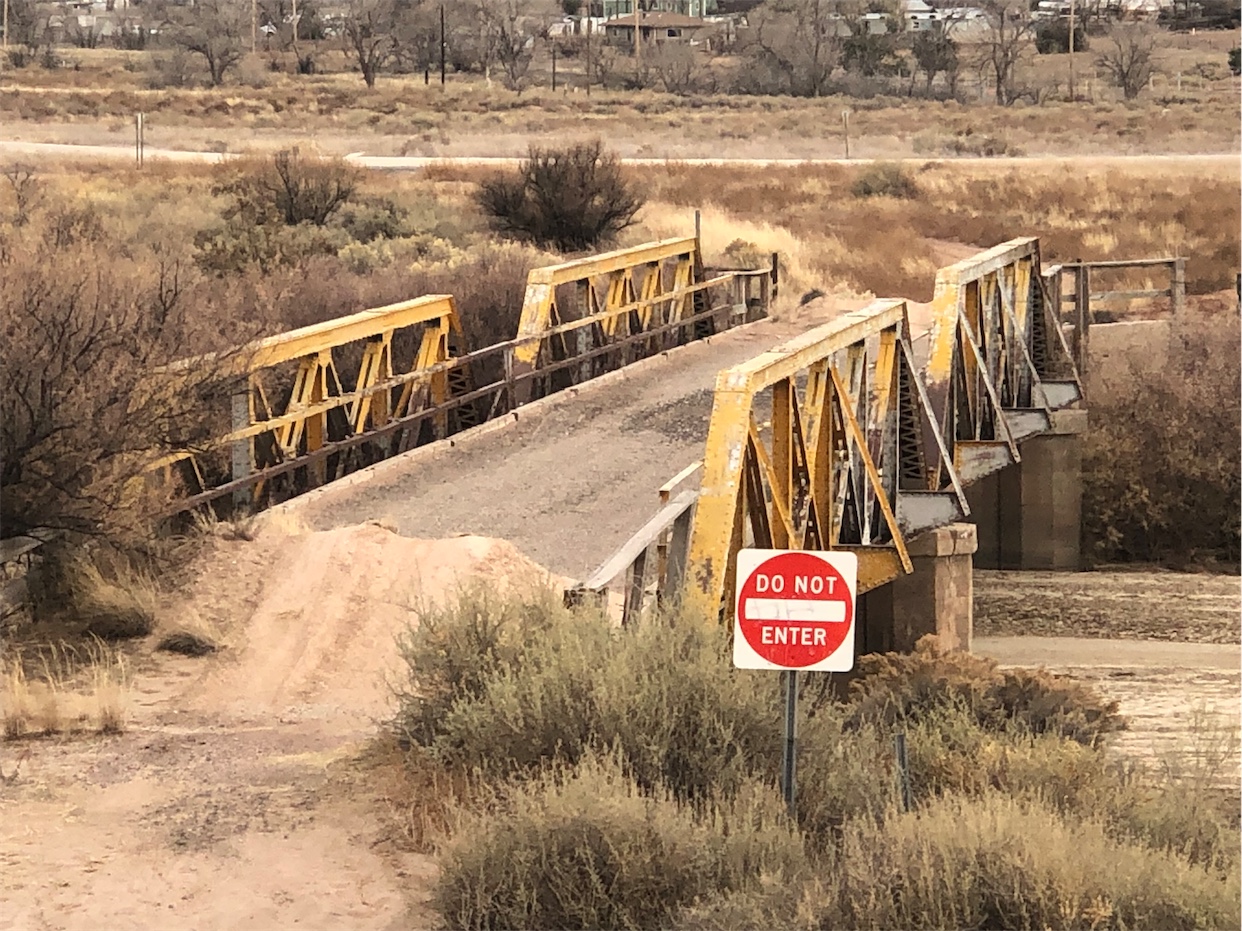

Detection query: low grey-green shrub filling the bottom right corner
(678, 793), (1240, 931)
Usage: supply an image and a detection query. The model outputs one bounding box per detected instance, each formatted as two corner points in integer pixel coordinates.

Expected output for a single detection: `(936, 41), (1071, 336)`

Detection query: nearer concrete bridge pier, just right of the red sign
(856, 524), (975, 654)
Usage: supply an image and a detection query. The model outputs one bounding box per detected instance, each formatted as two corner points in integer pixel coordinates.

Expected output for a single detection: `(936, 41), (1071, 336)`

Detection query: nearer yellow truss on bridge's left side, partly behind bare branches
(147, 294), (461, 509)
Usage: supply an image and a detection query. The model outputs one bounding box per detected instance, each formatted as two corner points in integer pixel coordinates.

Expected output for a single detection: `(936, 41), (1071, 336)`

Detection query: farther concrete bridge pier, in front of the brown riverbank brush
(966, 411), (1087, 571)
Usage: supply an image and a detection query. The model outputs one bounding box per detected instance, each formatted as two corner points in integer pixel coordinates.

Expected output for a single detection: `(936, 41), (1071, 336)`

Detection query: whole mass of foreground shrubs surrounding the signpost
(392, 588), (1238, 929)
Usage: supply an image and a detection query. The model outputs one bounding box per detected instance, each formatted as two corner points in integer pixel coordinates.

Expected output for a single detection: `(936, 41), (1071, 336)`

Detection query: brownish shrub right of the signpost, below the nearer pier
(851, 637), (1124, 746)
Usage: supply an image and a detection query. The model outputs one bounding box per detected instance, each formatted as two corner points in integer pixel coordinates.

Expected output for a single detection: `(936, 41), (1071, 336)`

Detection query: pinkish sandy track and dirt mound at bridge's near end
(0, 525), (556, 931)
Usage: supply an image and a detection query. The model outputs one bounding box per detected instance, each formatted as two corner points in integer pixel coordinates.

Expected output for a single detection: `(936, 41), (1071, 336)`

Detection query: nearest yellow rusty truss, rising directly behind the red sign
(683, 300), (968, 617)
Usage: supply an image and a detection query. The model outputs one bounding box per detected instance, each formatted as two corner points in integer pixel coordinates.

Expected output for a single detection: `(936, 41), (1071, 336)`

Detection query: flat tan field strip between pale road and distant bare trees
(0, 32), (1242, 158)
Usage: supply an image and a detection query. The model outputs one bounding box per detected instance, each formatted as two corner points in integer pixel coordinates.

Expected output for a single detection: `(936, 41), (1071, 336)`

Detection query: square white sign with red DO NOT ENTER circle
(733, 550), (858, 673)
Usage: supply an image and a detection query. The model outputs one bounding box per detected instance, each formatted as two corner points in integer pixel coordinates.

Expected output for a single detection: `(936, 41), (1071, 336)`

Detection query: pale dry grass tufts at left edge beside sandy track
(0, 639), (129, 740)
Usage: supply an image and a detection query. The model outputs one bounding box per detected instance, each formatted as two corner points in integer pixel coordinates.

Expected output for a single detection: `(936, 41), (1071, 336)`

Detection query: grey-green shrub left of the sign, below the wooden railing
(399, 592), (781, 798)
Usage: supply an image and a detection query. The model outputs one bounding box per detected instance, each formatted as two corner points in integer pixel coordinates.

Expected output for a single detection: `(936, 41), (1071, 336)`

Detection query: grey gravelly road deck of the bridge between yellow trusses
(286, 317), (818, 578)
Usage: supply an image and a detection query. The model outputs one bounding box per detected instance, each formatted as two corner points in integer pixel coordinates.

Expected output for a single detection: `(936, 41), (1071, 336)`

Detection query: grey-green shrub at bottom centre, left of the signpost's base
(435, 753), (802, 929)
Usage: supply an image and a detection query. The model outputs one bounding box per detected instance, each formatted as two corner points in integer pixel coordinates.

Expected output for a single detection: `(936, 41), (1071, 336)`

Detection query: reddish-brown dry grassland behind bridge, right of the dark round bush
(635, 161), (1242, 300)
